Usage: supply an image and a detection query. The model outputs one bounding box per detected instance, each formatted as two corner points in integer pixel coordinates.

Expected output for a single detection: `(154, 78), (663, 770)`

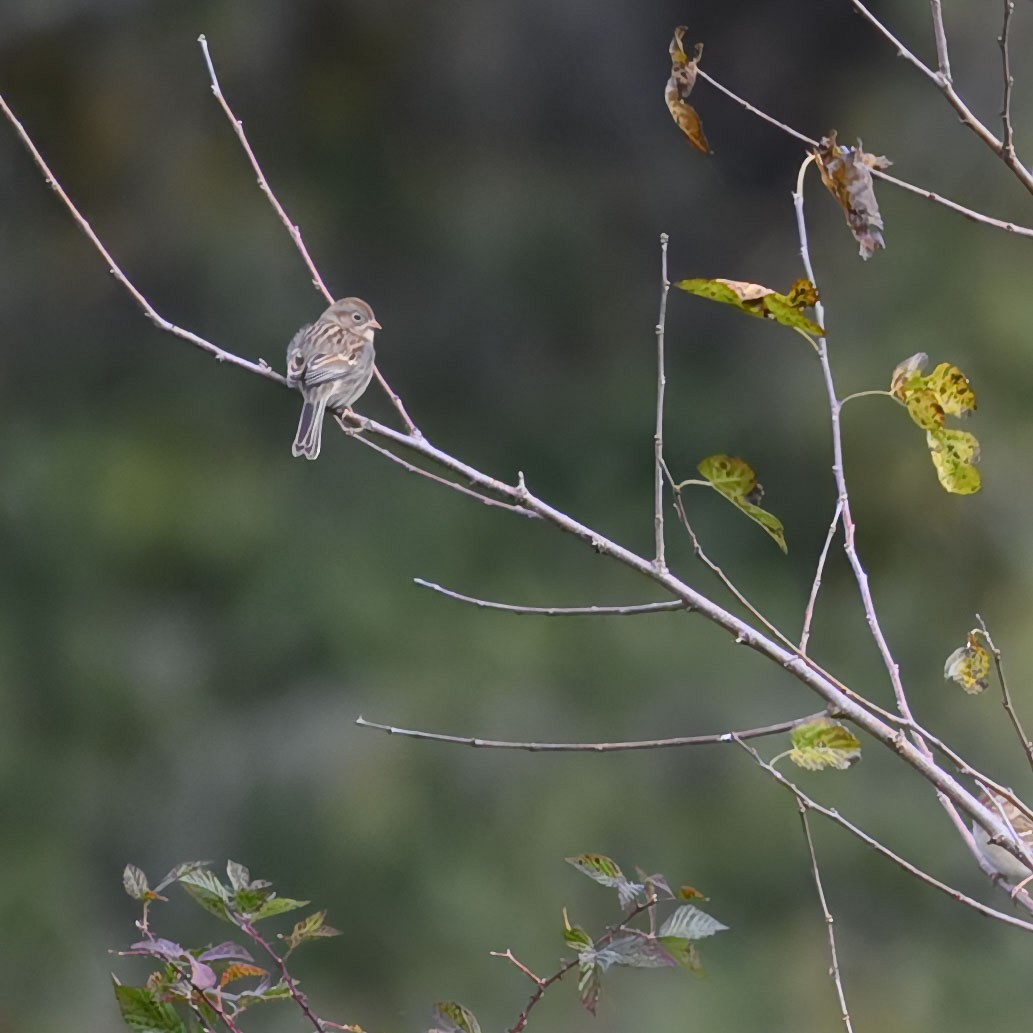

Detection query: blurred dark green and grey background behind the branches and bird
(0, 0), (1033, 1033)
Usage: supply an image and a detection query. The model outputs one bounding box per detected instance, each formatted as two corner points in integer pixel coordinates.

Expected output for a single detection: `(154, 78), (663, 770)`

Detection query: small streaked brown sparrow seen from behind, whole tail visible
(287, 298), (381, 459)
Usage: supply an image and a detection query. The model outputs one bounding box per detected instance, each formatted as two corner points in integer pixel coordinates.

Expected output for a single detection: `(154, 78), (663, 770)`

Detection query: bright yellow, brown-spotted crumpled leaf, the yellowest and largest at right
(889, 351), (980, 495)
